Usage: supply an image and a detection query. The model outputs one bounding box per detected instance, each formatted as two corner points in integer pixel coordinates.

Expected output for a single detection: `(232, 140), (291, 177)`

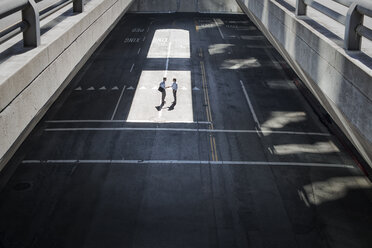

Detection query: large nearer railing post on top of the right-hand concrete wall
(344, 3), (363, 50)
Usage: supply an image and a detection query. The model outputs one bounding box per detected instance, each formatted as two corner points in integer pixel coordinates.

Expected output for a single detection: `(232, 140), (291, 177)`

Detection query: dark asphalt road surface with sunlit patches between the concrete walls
(0, 14), (372, 248)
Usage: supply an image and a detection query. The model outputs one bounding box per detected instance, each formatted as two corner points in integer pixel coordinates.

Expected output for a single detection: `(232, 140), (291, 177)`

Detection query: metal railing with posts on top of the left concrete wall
(0, 0), (84, 47)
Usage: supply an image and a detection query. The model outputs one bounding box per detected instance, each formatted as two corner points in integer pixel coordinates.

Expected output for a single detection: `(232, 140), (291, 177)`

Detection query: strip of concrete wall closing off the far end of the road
(130, 0), (242, 13)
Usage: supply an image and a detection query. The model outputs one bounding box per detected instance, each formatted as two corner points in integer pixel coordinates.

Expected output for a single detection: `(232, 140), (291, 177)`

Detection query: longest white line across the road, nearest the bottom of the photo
(22, 159), (355, 168)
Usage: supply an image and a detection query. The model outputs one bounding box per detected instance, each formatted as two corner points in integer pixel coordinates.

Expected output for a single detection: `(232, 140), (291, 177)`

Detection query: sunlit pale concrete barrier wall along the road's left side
(0, 0), (133, 170)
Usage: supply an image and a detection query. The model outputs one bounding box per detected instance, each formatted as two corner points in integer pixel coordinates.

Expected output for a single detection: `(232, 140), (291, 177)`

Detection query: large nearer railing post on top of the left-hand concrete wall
(22, 0), (40, 47)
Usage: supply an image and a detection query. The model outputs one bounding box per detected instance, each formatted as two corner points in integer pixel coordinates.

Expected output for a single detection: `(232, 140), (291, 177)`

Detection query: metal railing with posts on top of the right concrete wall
(296, 0), (372, 50)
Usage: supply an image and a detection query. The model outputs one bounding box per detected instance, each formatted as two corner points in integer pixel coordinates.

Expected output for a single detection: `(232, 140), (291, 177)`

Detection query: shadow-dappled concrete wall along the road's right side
(236, 0), (372, 167)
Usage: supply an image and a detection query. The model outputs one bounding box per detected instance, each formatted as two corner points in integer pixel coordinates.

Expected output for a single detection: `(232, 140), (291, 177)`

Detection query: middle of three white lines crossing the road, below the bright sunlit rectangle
(44, 127), (331, 136)
